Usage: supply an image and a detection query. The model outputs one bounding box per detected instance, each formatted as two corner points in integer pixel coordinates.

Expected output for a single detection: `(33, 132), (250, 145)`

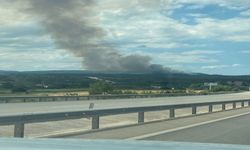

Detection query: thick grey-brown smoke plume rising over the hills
(25, 0), (174, 72)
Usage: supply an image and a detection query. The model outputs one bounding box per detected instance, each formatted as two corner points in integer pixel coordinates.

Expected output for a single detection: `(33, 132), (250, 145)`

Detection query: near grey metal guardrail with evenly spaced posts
(0, 99), (250, 137)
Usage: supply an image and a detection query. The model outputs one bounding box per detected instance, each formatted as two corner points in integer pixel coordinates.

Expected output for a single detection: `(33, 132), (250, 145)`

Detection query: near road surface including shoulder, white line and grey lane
(59, 107), (250, 145)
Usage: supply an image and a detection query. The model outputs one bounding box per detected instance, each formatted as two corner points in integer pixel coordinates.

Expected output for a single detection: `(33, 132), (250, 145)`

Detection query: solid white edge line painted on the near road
(127, 112), (250, 140)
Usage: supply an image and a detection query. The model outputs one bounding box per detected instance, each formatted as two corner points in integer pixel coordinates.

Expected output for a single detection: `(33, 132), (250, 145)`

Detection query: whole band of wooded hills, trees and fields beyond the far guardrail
(0, 71), (250, 96)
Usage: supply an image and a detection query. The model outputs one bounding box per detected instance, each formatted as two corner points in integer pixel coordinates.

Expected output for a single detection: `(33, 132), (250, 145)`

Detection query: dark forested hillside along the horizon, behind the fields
(0, 70), (250, 90)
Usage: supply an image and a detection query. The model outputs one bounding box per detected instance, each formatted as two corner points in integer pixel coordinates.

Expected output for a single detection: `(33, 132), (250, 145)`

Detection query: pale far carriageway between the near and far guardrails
(0, 92), (250, 116)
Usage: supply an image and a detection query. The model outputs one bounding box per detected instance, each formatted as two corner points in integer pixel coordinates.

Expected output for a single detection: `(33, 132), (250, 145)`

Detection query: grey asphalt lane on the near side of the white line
(144, 114), (250, 145)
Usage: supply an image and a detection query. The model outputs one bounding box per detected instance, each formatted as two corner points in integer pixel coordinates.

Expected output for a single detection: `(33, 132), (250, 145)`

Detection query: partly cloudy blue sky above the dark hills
(0, 0), (250, 75)
